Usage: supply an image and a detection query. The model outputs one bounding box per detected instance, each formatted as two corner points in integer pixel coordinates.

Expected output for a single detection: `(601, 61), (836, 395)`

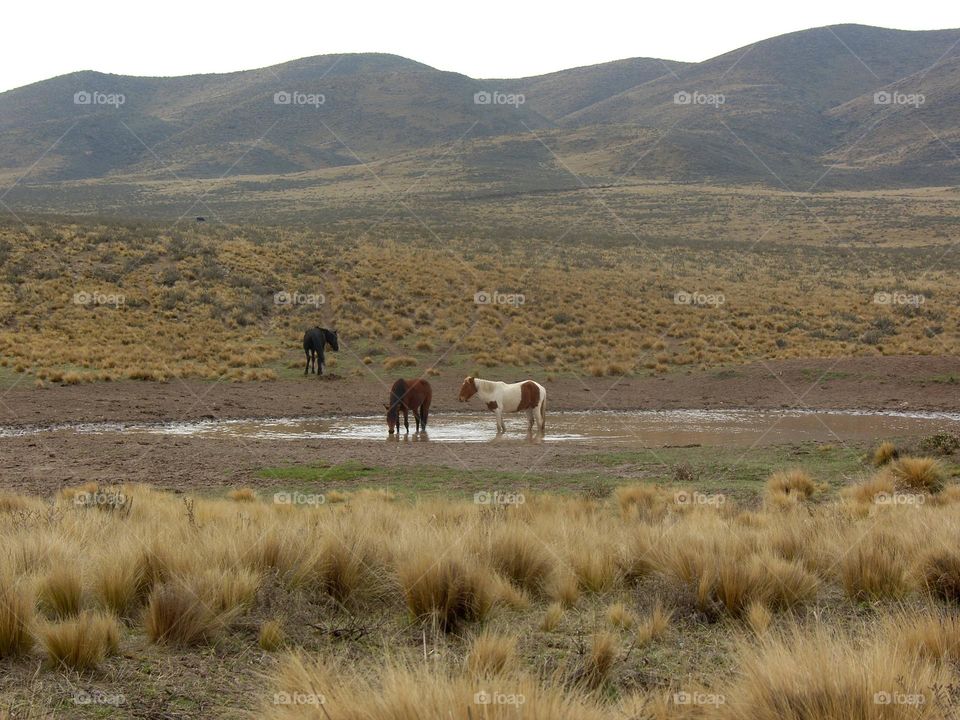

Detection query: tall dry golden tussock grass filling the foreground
(0, 449), (960, 720)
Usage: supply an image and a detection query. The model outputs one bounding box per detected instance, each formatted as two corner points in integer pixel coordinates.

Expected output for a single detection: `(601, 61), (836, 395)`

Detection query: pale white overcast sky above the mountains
(0, 0), (960, 91)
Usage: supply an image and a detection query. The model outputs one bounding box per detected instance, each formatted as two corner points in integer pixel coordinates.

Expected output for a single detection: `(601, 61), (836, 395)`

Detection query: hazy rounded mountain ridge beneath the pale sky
(0, 25), (960, 193)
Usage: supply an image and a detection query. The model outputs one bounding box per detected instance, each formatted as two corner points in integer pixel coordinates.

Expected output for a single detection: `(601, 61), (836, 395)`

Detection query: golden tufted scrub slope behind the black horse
(0, 221), (960, 384)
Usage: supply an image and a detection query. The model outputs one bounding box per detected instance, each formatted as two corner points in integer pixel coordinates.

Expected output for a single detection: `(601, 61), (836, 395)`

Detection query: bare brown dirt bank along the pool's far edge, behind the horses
(0, 357), (960, 425)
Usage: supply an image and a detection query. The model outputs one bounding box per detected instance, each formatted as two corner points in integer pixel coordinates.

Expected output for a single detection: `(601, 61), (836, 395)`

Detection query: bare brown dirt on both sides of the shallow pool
(0, 357), (960, 493)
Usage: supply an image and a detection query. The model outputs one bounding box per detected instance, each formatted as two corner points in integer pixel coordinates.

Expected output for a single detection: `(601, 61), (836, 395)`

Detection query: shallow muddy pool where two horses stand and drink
(0, 410), (960, 447)
